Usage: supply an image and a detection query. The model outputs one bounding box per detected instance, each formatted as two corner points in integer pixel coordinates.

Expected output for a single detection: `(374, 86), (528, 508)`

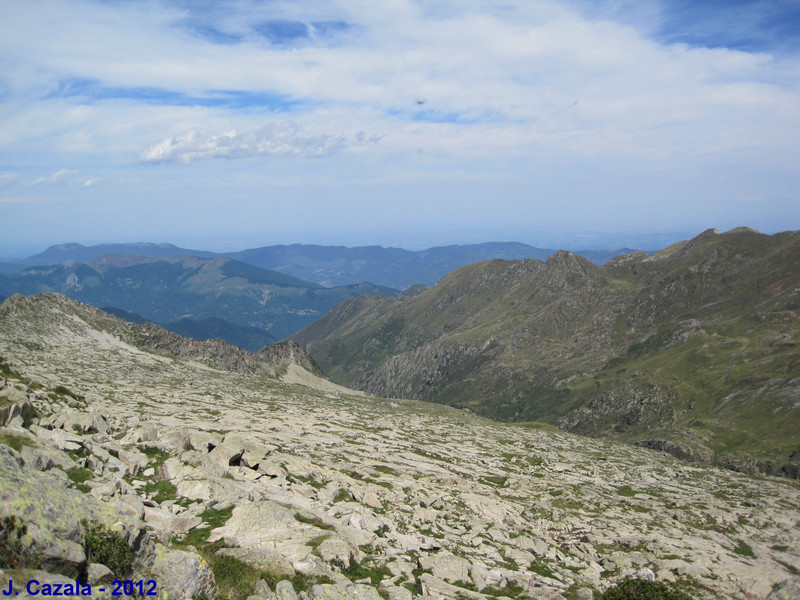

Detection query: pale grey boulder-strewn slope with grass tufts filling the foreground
(0, 295), (800, 600)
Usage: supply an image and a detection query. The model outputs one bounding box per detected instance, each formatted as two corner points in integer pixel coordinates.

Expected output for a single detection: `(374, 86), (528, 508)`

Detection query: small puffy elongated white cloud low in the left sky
(139, 122), (346, 164)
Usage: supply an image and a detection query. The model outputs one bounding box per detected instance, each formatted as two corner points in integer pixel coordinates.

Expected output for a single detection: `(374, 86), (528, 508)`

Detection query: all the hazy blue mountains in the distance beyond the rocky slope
(0, 242), (640, 352)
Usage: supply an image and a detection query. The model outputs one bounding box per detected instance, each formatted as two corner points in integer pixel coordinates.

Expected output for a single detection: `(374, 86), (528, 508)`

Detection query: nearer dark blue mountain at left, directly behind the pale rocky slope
(0, 254), (397, 351)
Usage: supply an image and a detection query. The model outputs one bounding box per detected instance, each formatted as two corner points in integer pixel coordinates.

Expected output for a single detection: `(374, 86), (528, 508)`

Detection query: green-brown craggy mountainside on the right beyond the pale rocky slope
(294, 228), (800, 474)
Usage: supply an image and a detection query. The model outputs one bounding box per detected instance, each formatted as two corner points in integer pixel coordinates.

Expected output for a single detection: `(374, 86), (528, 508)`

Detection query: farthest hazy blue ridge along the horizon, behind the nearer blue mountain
(0, 242), (634, 289)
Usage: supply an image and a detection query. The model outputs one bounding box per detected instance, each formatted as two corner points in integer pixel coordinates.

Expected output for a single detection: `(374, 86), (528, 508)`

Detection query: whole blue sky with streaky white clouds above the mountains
(0, 0), (800, 256)
